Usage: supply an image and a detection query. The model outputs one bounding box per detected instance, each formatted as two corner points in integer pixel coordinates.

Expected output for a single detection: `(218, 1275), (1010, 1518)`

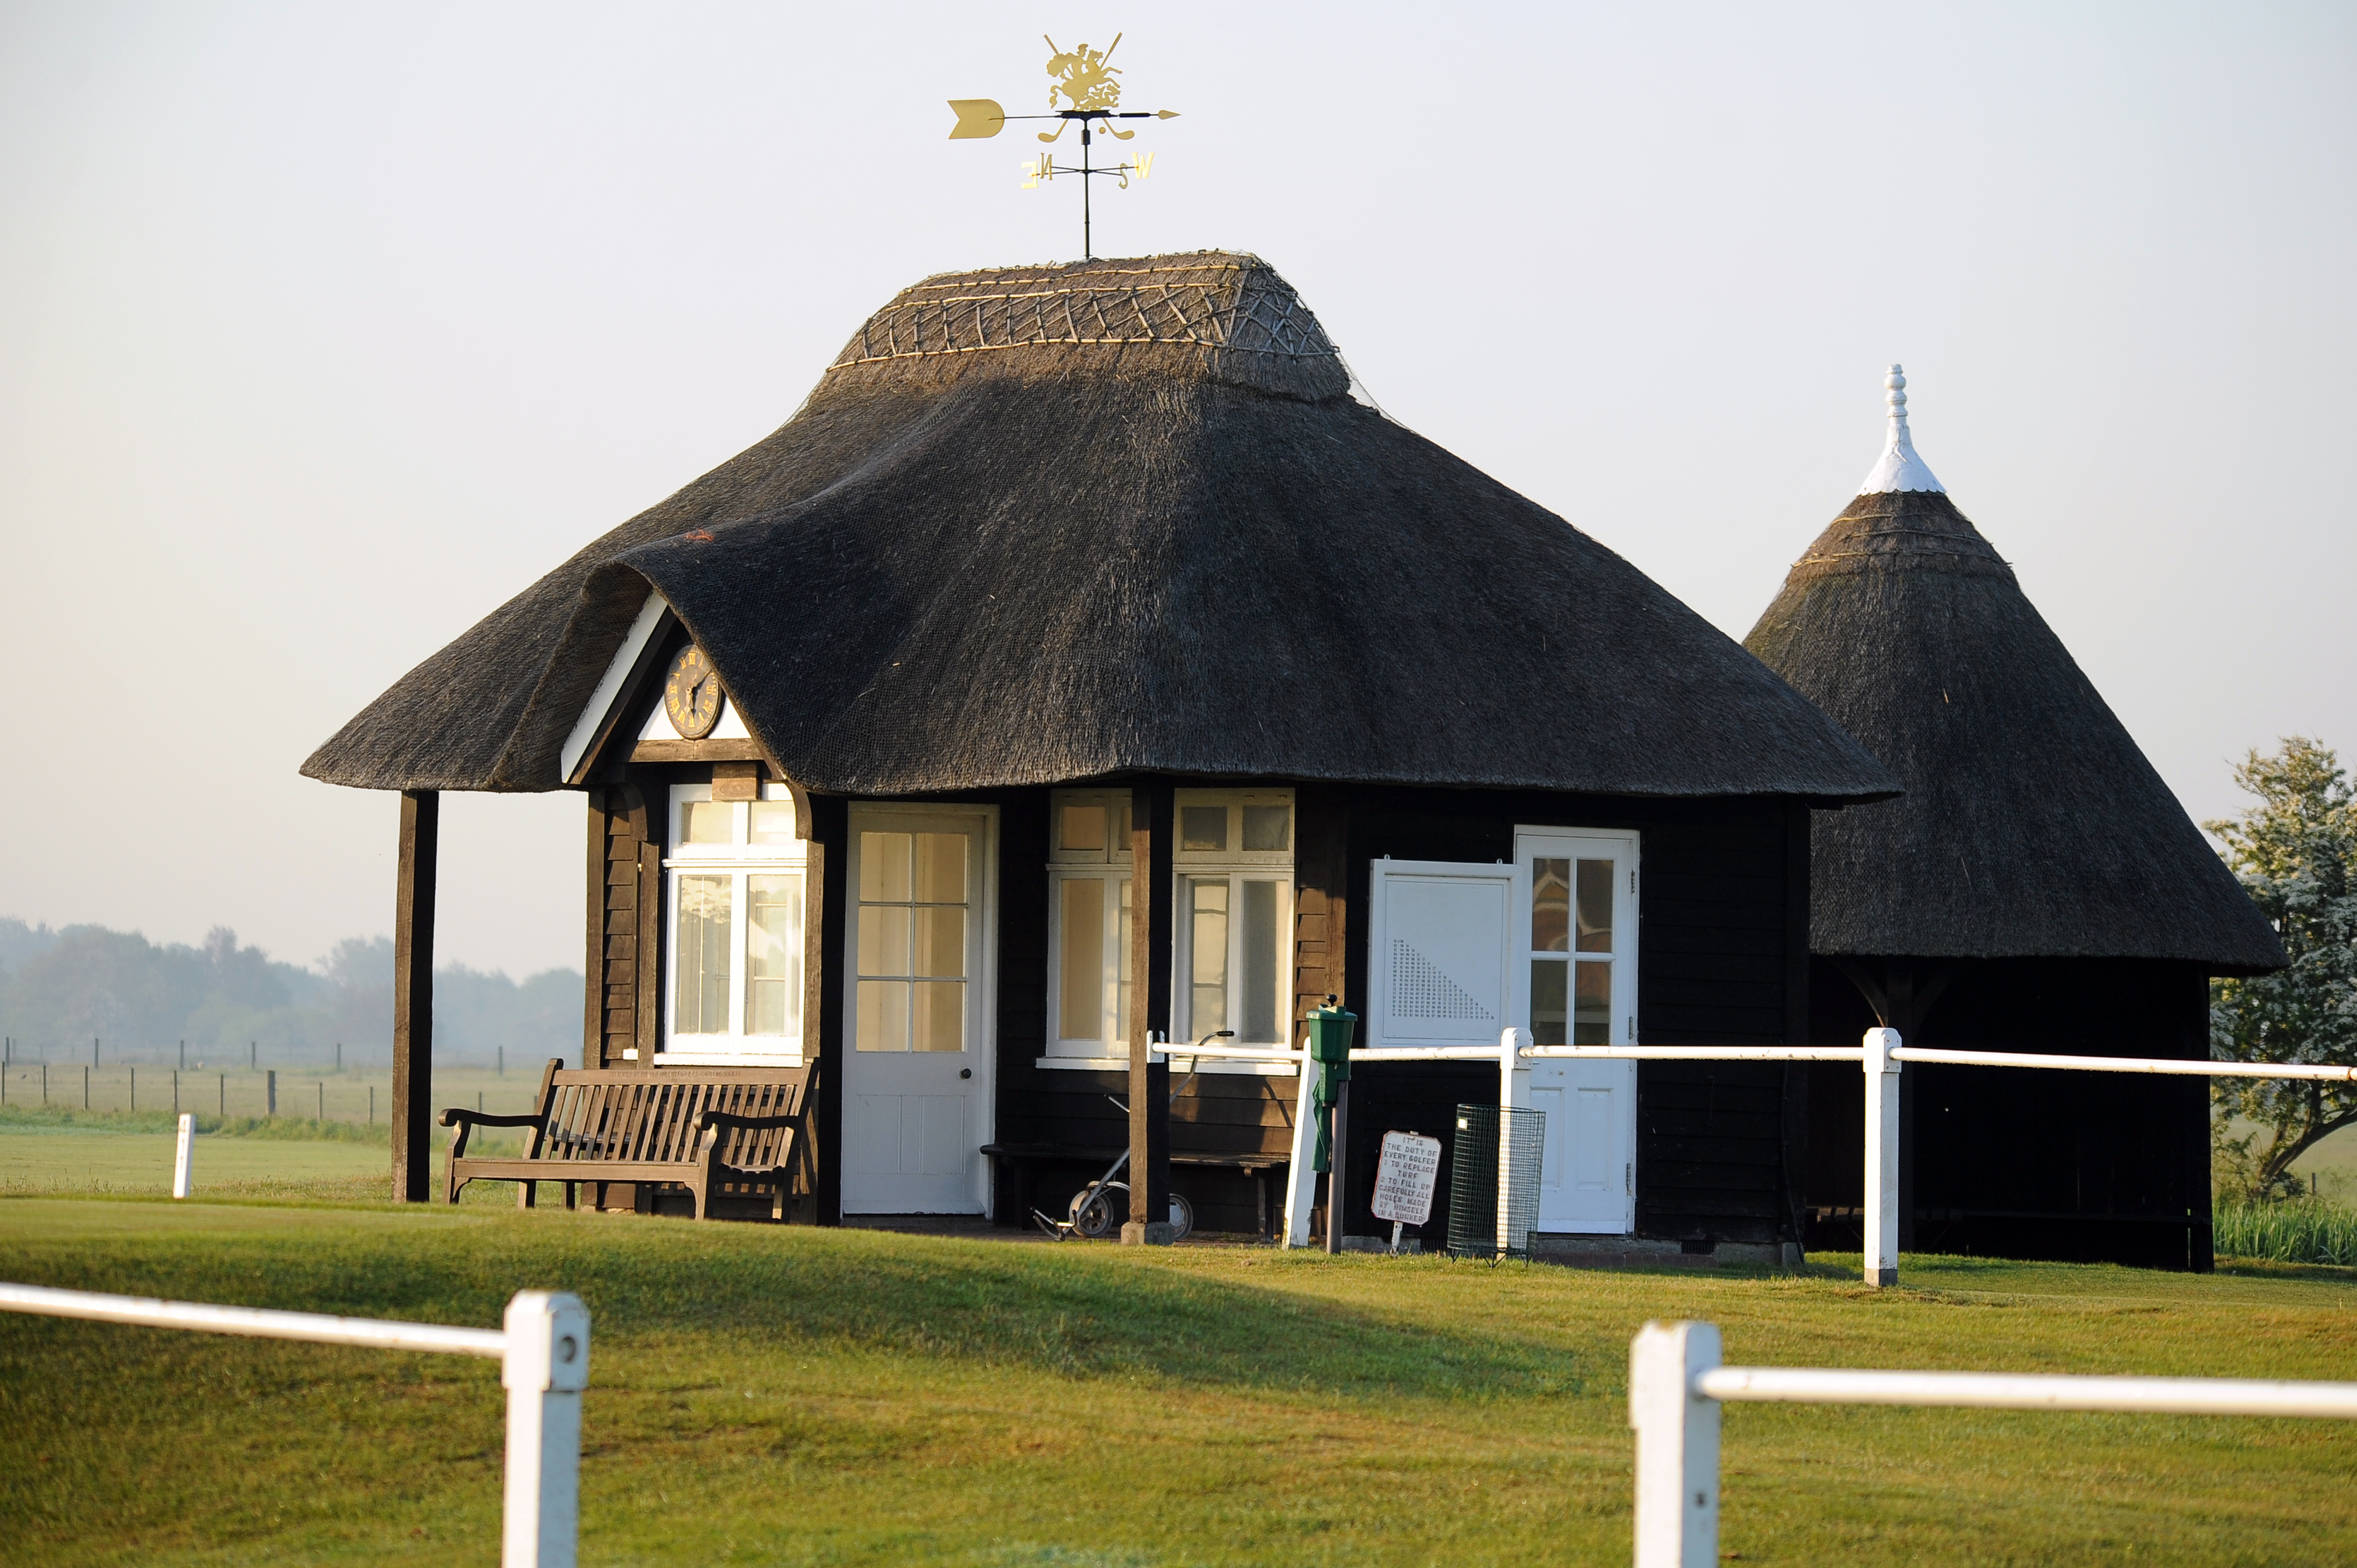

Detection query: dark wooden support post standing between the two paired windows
(1122, 781), (1176, 1247)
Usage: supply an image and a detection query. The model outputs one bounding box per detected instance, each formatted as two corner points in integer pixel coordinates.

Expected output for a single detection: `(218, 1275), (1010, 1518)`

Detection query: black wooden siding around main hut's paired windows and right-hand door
(928, 785), (1808, 1240)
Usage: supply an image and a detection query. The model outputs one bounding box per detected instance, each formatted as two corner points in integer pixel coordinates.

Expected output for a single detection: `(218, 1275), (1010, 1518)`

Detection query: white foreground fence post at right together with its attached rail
(1629, 1323), (2357, 1568)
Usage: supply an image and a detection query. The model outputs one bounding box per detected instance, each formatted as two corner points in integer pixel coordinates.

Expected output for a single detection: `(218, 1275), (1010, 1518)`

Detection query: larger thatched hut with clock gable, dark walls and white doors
(304, 252), (1897, 1257)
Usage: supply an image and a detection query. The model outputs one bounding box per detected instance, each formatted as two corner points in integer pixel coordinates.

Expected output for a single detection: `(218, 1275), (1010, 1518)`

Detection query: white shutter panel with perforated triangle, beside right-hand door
(1367, 860), (1516, 1049)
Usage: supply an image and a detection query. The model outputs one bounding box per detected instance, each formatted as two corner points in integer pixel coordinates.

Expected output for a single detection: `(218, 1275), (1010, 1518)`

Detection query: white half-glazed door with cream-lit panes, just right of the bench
(844, 806), (997, 1214)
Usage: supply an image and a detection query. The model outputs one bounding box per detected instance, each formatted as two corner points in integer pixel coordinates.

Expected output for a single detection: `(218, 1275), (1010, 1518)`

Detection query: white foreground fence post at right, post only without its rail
(1629, 1323), (1718, 1568)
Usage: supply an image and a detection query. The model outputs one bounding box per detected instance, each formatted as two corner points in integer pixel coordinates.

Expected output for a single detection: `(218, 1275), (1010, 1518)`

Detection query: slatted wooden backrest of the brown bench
(540, 1068), (811, 1167)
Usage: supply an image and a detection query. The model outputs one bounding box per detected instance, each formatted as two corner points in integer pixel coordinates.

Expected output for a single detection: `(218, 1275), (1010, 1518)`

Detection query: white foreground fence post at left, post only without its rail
(500, 1290), (589, 1568)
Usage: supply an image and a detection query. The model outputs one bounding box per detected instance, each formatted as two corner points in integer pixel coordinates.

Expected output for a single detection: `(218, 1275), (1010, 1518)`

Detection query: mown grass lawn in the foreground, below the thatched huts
(0, 1198), (2357, 1568)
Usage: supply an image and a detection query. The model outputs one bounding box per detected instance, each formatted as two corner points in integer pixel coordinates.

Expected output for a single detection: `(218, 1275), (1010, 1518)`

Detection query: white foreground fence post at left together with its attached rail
(0, 1285), (589, 1568)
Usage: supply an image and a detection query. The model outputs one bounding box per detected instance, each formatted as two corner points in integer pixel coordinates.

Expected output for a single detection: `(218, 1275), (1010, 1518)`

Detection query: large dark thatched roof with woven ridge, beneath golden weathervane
(304, 252), (1895, 802)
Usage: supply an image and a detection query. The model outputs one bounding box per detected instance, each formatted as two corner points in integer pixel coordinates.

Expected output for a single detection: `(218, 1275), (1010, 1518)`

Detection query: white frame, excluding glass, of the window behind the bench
(655, 783), (818, 1068)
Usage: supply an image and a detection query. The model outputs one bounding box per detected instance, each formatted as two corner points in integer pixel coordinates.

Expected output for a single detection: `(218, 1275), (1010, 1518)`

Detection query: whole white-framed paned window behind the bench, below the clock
(655, 785), (806, 1064)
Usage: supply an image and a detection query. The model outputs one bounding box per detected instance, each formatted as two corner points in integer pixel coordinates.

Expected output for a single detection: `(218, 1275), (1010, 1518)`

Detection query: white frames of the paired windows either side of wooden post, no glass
(1037, 790), (1301, 1077)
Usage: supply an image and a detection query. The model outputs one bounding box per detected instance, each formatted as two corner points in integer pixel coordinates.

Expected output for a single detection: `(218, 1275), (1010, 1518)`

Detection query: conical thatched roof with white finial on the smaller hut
(1744, 365), (2284, 972)
